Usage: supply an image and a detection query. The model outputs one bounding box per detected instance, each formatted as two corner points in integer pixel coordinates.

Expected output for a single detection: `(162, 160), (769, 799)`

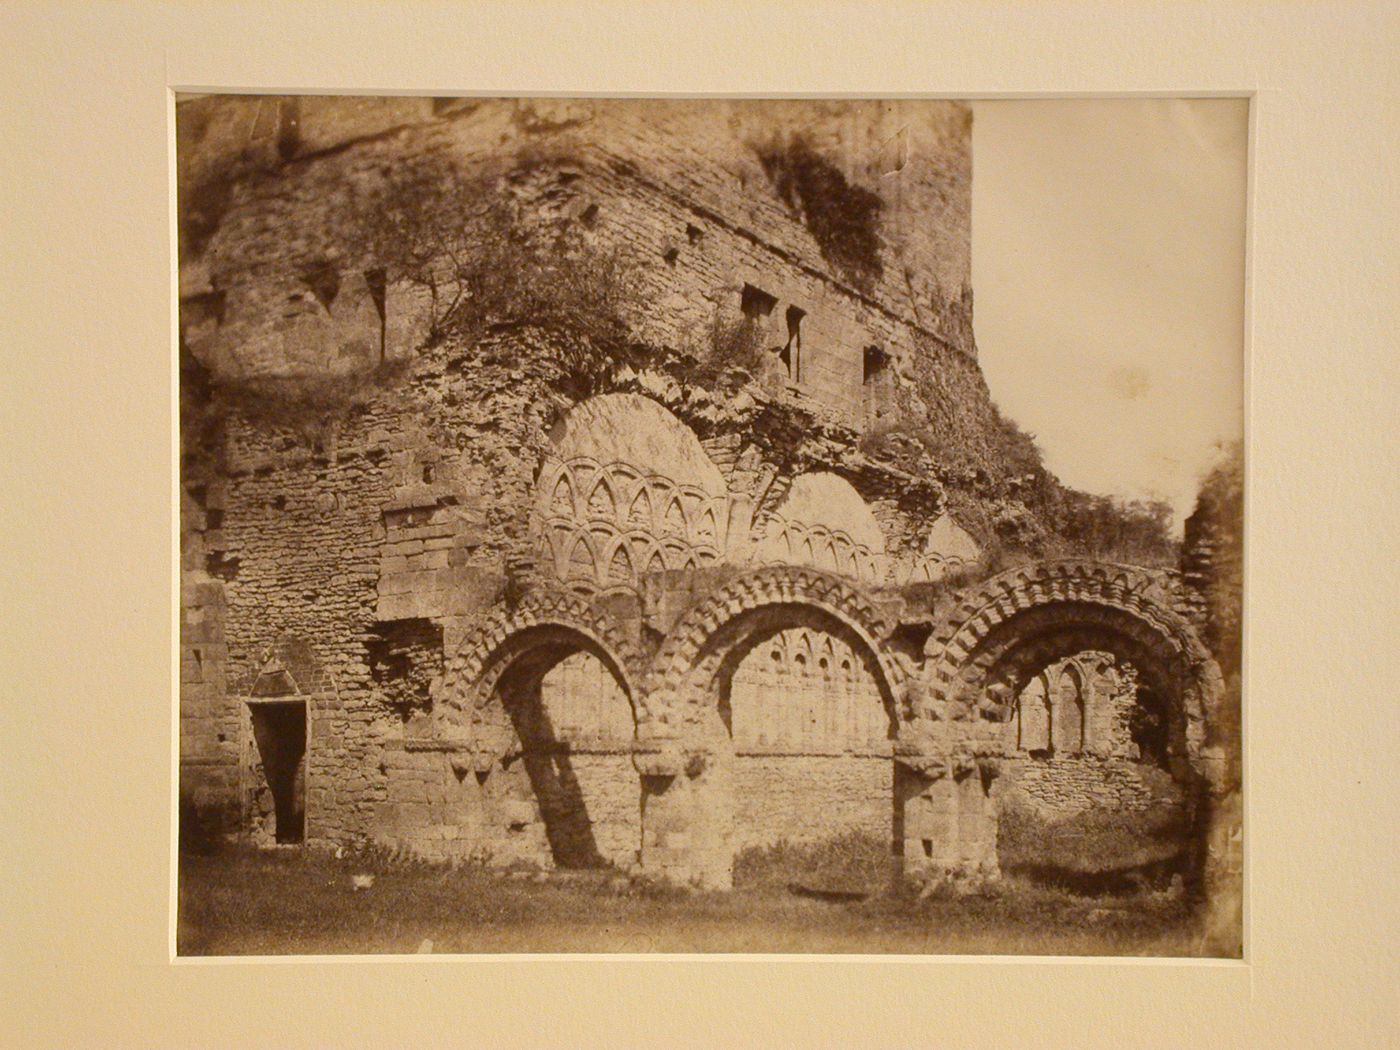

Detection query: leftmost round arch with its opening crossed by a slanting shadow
(434, 594), (641, 868)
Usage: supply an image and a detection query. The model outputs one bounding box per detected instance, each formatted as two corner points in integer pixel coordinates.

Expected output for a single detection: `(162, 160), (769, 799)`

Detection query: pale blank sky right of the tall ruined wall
(972, 99), (1247, 525)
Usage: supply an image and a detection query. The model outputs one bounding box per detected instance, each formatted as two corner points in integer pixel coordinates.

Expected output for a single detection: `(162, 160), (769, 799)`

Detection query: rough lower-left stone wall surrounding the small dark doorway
(182, 329), (562, 840)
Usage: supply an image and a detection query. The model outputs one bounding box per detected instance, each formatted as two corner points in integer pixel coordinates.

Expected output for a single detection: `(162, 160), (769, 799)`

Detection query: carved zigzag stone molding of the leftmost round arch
(434, 589), (645, 755)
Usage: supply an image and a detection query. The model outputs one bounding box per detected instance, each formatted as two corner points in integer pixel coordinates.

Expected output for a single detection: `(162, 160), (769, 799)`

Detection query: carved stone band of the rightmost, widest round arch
(914, 560), (1222, 776)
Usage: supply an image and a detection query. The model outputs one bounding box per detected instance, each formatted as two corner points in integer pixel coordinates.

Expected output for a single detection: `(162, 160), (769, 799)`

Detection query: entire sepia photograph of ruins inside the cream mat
(174, 92), (1250, 959)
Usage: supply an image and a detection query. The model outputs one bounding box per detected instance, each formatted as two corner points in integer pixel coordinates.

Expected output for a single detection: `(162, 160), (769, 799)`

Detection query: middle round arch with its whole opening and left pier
(643, 567), (902, 886)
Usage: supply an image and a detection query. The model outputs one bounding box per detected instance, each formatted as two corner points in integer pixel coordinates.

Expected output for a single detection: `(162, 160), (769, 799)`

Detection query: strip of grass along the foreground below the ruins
(176, 847), (1211, 956)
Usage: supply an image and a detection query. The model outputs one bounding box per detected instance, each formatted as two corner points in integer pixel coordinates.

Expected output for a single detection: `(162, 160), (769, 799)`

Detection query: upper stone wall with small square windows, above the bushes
(179, 98), (986, 445)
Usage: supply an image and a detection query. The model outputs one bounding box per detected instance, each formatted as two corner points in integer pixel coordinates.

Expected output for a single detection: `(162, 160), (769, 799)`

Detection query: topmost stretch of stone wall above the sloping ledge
(176, 97), (972, 343)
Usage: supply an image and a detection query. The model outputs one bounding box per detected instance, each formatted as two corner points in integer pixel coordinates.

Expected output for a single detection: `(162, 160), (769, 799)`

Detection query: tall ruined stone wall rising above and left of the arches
(178, 98), (1058, 855)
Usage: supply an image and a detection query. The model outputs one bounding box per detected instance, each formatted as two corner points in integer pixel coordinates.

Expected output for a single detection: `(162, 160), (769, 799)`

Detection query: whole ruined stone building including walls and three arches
(178, 97), (1222, 888)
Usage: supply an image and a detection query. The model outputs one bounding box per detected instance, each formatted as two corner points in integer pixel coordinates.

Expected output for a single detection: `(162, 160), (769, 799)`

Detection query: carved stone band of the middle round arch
(647, 566), (904, 729)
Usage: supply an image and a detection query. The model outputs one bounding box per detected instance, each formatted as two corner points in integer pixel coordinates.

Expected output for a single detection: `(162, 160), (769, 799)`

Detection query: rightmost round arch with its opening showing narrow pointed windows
(924, 561), (1239, 896)
